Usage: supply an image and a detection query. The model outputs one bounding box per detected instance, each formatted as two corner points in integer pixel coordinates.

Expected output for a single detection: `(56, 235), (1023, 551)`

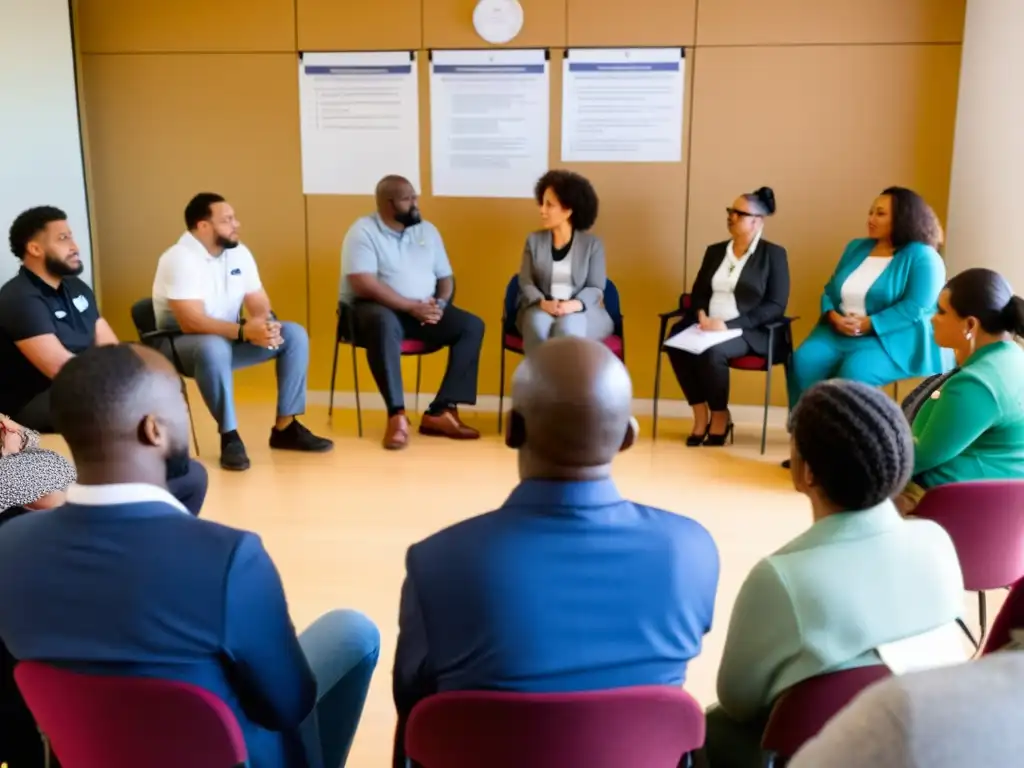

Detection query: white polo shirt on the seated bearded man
(153, 232), (263, 329)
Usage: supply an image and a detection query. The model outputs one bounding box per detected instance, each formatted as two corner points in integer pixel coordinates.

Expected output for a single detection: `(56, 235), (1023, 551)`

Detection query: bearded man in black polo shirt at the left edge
(0, 206), (118, 432)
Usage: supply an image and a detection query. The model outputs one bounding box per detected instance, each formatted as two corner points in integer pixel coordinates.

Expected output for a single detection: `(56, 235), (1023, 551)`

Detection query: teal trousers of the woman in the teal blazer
(788, 325), (908, 408)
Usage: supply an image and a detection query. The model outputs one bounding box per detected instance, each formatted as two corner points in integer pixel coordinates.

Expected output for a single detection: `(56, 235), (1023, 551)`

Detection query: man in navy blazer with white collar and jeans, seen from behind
(0, 345), (380, 768)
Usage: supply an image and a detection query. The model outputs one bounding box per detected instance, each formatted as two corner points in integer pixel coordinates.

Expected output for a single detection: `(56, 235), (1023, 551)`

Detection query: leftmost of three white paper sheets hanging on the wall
(299, 50), (420, 195)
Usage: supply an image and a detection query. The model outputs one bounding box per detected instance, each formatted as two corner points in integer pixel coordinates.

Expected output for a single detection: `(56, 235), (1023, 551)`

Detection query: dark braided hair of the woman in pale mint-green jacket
(790, 379), (913, 511)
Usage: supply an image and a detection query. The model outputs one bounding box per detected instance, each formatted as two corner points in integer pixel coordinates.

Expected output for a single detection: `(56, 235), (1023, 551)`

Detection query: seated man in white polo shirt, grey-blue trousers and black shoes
(153, 193), (334, 470)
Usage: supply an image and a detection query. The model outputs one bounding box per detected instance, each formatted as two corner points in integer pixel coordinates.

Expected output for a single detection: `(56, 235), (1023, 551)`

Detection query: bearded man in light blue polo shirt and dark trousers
(340, 176), (483, 451)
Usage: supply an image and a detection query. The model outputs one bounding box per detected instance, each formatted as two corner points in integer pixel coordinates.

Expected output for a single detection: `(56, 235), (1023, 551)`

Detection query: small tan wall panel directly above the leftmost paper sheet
(295, 0), (423, 51)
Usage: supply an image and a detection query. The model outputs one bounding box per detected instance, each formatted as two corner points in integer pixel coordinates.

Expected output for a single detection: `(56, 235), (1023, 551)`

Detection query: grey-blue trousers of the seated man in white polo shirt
(161, 323), (309, 434)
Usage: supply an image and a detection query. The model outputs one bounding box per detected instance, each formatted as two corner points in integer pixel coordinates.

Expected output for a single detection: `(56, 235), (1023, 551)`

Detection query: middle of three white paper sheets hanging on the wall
(430, 49), (551, 198)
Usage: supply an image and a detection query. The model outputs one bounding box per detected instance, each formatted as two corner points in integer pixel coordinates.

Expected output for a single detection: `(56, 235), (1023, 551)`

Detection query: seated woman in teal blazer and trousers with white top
(788, 186), (949, 407)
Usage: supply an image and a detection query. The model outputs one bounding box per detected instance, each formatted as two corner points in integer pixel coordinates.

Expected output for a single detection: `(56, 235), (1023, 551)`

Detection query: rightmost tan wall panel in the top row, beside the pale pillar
(697, 0), (966, 46)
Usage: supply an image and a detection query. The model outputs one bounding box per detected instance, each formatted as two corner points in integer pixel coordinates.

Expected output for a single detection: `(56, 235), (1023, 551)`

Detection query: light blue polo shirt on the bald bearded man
(339, 214), (452, 303)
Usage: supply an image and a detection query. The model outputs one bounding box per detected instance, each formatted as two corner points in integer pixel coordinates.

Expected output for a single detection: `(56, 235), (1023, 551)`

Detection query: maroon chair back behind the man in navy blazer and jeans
(14, 662), (247, 768)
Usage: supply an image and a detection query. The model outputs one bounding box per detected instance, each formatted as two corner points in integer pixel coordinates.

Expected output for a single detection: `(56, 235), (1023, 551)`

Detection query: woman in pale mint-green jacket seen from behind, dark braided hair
(707, 380), (964, 768)
